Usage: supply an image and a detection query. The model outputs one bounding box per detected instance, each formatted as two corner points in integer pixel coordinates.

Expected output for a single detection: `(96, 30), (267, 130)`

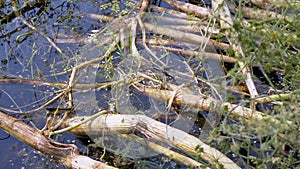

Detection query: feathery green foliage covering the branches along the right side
(200, 4), (300, 168)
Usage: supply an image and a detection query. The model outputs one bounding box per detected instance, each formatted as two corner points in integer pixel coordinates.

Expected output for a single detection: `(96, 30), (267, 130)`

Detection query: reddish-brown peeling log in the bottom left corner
(0, 112), (114, 169)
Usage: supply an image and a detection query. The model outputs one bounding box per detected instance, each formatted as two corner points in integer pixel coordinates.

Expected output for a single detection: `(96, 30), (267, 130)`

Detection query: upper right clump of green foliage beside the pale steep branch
(235, 16), (300, 90)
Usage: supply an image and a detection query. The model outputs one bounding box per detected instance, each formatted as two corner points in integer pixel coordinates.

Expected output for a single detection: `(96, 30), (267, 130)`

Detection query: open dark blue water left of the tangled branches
(0, 0), (112, 169)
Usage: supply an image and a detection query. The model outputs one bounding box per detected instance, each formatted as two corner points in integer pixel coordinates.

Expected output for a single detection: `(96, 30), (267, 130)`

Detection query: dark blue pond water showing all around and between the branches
(0, 0), (298, 169)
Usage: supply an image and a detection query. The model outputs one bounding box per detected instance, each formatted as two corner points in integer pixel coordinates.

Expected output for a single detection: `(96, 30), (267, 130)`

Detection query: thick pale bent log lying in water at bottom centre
(65, 114), (240, 169)
